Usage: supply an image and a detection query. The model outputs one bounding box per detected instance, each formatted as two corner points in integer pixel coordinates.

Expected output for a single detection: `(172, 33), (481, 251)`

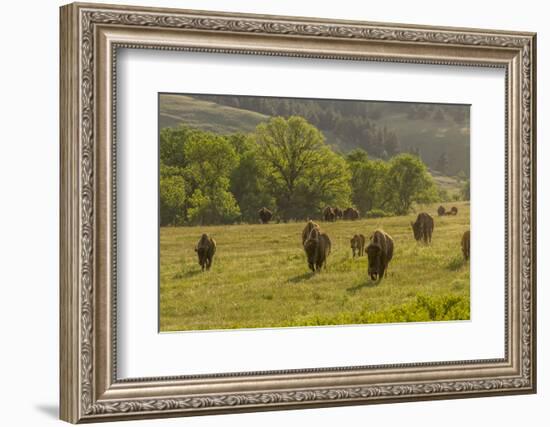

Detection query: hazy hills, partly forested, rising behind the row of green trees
(159, 95), (470, 176)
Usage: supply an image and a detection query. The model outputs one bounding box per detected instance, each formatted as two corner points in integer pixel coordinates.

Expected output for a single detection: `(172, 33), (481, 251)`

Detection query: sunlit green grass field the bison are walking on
(160, 202), (470, 331)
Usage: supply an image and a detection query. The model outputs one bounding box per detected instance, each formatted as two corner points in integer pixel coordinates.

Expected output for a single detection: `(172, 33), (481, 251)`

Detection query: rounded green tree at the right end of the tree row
(384, 154), (438, 215)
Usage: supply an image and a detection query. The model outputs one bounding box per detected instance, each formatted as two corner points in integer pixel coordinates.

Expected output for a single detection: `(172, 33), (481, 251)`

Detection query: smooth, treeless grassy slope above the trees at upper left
(159, 95), (268, 134)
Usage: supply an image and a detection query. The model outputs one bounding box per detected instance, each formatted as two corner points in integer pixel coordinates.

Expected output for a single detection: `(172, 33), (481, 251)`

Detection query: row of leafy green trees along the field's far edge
(160, 116), (452, 225)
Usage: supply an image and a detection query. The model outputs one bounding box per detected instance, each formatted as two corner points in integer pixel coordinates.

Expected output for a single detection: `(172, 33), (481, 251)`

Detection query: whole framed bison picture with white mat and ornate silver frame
(60, 4), (536, 423)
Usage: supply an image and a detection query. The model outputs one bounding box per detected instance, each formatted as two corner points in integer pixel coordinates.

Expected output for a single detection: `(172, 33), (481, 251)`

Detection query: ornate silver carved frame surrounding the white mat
(60, 4), (536, 423)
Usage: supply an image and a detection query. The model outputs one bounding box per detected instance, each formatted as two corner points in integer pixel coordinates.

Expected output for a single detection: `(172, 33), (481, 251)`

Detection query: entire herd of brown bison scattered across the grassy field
(195, 206), (470, 280)
